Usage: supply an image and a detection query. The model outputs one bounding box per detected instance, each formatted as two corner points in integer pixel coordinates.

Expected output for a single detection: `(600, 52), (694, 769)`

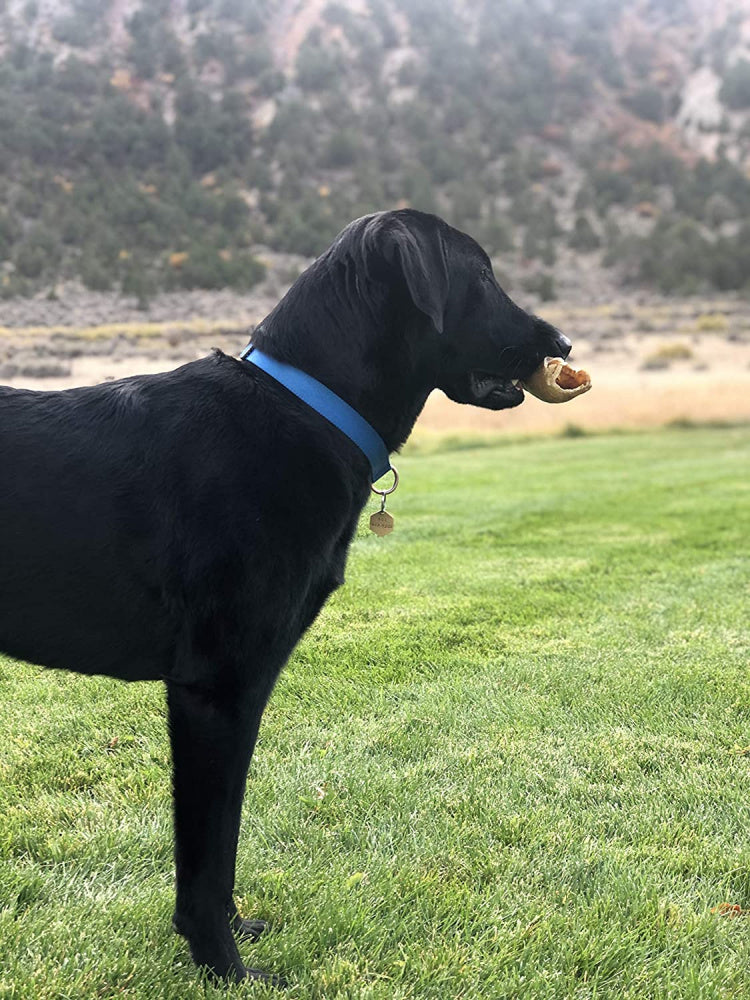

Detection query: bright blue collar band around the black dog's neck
(240, 344), (391, 482)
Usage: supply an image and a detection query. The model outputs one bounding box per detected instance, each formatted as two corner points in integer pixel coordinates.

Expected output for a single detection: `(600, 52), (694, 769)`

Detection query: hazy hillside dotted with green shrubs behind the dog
(0, 0), (750, 304)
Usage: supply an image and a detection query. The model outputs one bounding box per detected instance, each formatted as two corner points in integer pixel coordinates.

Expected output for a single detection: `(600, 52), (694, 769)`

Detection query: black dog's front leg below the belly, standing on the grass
(167, 680), (270, 979)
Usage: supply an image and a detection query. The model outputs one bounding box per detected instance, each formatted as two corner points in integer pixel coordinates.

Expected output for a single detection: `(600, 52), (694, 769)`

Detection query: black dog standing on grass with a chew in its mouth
(0, 210), (570, 978)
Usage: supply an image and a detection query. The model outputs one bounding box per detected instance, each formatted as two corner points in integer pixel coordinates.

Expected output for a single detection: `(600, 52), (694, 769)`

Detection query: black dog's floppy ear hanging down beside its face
(365, 214), (448, 333)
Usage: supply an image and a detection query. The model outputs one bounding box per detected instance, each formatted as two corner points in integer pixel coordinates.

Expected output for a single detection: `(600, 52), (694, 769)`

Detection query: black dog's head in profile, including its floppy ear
(358, 209), (571, 410)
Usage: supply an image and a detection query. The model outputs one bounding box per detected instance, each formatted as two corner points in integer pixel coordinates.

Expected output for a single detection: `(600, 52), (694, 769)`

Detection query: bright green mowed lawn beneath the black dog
(0, 427), (750, 1000)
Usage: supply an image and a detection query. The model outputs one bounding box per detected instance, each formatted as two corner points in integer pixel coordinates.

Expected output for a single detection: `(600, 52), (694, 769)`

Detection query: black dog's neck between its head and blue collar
(251, 265), (434, 451)
